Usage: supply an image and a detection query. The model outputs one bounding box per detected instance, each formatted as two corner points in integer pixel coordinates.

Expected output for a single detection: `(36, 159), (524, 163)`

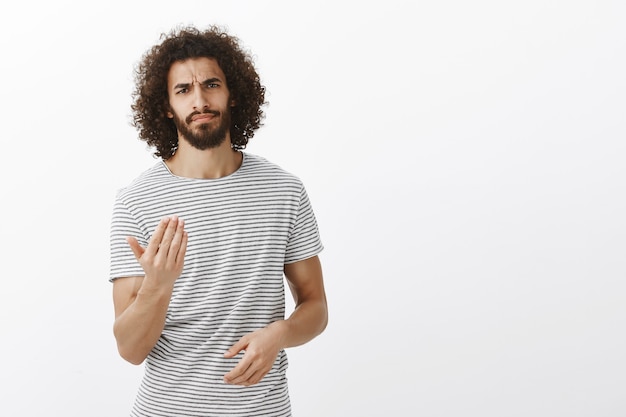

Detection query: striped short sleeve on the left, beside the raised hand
(109, 195), (148, 281)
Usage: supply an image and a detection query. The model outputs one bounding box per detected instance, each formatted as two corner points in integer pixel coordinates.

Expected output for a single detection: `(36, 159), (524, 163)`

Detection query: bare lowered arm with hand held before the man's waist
(224, 256), (328, 385)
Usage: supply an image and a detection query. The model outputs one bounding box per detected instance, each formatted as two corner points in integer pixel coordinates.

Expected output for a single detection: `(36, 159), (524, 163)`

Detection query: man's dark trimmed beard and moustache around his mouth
(172, 110), (230, 151)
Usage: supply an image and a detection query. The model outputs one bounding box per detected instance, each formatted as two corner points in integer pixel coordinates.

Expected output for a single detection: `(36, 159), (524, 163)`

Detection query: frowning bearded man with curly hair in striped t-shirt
(110, 27), (327, 417)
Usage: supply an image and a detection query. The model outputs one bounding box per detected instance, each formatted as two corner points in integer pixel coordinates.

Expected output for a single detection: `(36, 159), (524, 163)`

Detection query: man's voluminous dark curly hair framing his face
(131, 25), (266, 160)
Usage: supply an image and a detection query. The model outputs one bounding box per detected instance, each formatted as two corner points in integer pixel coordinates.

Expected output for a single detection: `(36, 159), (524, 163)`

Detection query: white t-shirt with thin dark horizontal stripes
(110, 153), (322, 417)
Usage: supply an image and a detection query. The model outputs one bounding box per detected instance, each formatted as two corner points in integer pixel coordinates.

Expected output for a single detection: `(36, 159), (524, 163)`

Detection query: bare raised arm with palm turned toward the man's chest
(113, 217), (187, 365)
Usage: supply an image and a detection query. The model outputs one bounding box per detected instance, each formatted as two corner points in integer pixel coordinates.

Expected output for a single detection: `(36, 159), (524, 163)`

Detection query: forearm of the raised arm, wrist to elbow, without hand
(113, 288), (172, 365)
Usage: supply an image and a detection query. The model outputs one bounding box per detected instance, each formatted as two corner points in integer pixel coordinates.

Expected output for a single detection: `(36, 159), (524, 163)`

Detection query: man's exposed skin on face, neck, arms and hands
(113, 58), (328, 386)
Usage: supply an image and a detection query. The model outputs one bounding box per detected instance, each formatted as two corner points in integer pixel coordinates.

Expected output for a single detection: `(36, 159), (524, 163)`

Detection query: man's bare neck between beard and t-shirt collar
(165, 138), (243, 179)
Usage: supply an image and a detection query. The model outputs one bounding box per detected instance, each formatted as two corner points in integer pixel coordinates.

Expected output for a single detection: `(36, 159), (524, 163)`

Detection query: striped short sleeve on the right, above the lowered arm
(285, 186), (324, 264)
